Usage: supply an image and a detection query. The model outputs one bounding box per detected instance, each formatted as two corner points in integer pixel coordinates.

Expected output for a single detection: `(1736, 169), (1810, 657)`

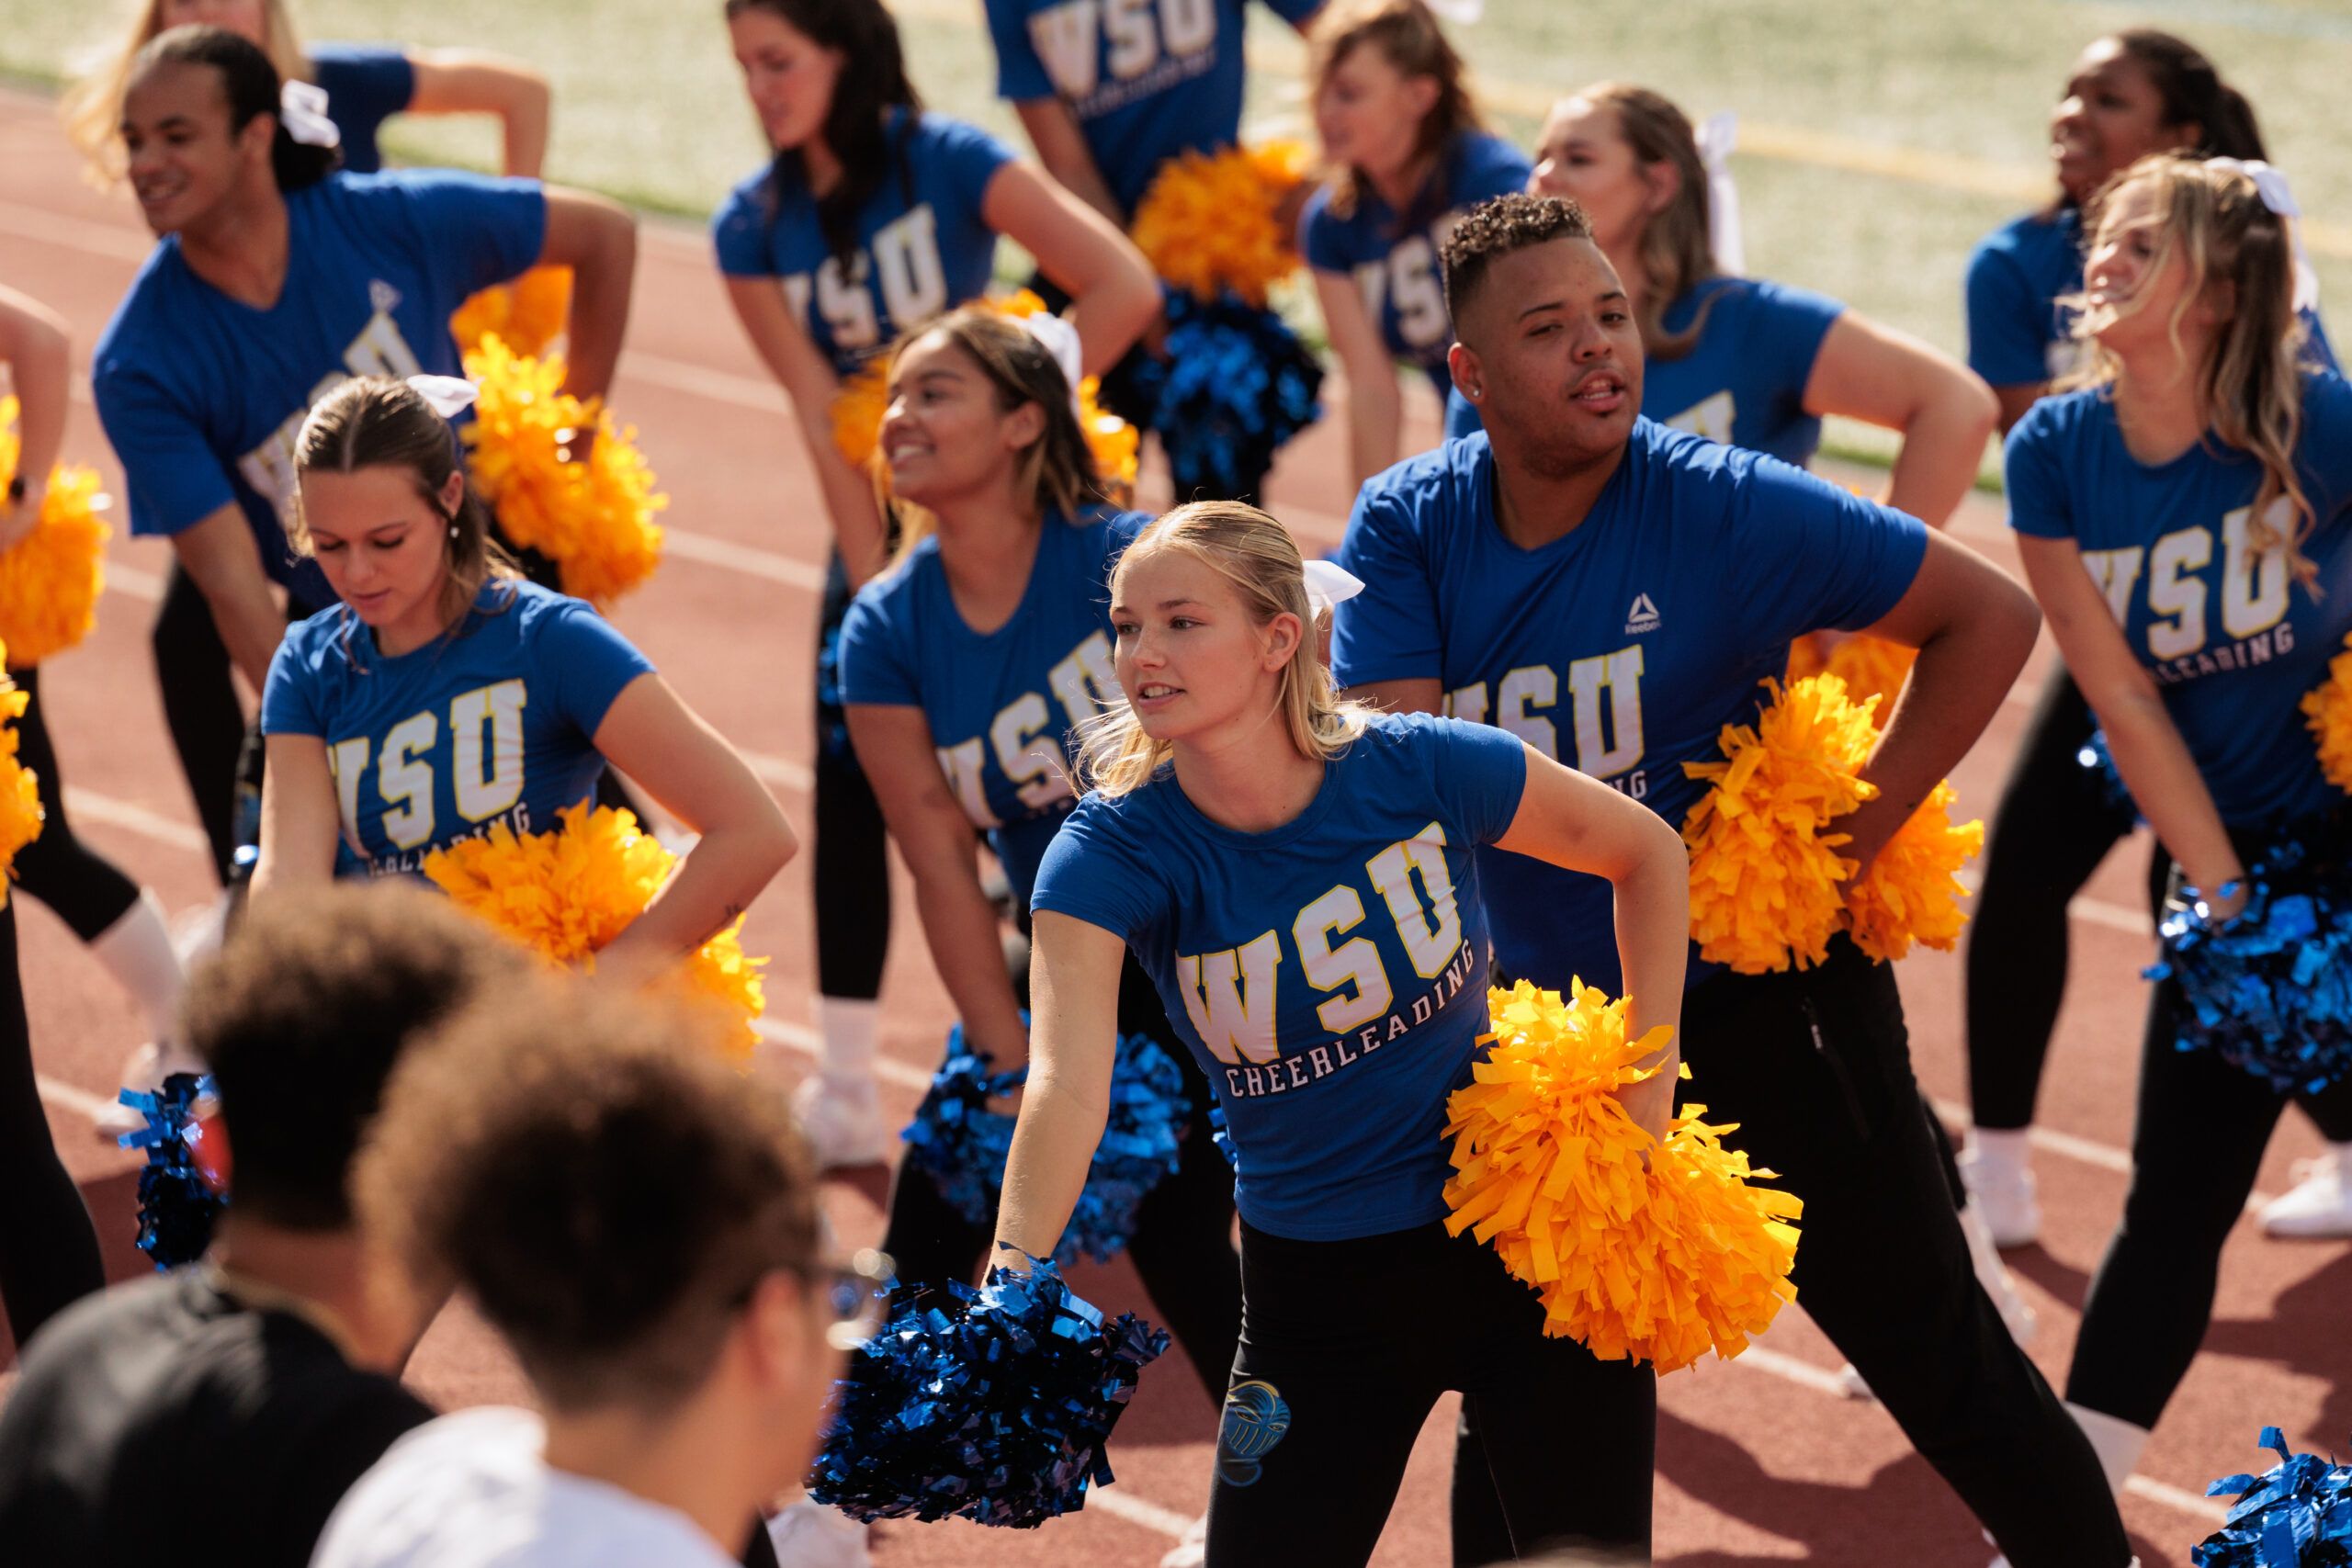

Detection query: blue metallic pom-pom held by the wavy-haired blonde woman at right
(2147, 825), (2352, 1093)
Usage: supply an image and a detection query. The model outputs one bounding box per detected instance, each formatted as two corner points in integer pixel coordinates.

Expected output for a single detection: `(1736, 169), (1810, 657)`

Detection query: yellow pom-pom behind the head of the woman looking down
(466, 333), (671, 604)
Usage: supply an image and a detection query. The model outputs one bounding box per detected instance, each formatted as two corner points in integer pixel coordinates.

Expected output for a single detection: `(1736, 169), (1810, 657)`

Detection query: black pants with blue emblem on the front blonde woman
(1209, 1223), (1658, 1568)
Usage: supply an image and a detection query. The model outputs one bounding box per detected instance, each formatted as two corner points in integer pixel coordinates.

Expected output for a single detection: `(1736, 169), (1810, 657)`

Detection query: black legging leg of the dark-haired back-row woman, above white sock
(809, 555), (889, 1001)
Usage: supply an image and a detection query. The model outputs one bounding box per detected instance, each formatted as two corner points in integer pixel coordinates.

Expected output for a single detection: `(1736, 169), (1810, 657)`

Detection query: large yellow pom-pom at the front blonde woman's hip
(1446, 980), (1804, 1373)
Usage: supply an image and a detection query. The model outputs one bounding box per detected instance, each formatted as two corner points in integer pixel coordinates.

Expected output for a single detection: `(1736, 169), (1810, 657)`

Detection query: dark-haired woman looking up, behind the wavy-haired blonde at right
(1962, 28), (2352, 1246)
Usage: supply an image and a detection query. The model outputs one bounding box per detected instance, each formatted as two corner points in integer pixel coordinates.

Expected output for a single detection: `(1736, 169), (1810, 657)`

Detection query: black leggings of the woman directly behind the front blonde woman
(882, 957), (1242, 1404)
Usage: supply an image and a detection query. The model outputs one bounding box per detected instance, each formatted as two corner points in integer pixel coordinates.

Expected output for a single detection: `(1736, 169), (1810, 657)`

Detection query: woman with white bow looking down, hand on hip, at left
(254, 376), (793, 974)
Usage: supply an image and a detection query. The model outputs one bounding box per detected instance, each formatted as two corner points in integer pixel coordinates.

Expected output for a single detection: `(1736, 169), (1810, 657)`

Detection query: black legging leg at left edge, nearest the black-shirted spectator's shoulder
(0, 903), (106, 1354)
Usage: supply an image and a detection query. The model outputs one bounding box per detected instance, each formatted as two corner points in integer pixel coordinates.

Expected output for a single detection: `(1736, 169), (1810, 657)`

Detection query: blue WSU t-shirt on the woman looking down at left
(261, 583), (654, 877)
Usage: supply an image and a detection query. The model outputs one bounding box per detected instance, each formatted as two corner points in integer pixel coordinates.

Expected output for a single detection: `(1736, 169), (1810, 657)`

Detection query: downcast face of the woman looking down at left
(301, 466), (466, 656)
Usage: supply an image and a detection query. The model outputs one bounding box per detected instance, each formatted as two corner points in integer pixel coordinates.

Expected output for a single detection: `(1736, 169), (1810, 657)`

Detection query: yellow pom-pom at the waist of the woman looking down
(424, 804), (767, 1060)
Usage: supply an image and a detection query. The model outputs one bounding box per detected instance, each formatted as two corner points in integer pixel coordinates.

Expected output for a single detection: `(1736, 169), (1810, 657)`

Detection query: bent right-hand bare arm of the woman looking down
(595, 674), (797, 974)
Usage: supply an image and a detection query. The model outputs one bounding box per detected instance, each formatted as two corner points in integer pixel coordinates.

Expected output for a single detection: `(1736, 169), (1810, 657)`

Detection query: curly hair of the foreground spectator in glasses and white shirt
(356, 980), (819, 1413)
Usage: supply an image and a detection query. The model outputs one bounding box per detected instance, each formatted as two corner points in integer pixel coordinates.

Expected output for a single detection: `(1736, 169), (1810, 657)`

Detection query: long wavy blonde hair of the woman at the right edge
(2058, 152), (2317, 592)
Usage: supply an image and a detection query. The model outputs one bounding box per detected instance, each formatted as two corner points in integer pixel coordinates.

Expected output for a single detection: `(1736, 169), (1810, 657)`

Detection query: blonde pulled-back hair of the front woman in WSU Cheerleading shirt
(1077, 501), (1374, 797)
